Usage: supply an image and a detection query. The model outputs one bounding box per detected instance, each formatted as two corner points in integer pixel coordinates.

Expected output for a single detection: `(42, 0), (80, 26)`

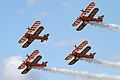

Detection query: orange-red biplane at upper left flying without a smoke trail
(18, 21), (49, 48)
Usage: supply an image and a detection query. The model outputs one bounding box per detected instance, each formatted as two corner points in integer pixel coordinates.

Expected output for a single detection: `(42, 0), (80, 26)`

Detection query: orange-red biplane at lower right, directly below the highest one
(65, 41), (96, 65)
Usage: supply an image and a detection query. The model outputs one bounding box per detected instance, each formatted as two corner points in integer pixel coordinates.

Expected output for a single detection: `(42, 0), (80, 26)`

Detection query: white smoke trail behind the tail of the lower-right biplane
(93, 59), (120, 68)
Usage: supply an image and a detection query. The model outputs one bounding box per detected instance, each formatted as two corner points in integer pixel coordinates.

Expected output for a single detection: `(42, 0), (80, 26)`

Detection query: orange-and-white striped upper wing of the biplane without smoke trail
(18, 21), (40, 43)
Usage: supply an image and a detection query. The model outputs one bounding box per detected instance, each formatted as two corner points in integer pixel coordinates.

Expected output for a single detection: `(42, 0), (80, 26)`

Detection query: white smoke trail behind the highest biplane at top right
(88, 21), (120, 31)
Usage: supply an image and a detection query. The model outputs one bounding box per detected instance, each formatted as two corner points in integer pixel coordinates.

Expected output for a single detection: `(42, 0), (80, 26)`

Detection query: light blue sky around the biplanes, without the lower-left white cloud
(0, 0), (120, 80)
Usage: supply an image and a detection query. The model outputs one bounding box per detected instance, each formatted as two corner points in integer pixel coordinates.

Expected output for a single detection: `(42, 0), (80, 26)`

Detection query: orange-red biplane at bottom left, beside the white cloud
(18, 50), (48, 74)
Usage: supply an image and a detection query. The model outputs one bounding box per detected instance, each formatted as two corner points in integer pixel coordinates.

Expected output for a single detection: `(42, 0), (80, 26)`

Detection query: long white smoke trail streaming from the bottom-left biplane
(34, 67), (120, 80)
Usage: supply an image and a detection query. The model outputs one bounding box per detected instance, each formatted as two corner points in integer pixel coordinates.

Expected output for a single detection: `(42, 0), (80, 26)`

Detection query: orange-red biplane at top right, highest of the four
(72, 2), (104, 31)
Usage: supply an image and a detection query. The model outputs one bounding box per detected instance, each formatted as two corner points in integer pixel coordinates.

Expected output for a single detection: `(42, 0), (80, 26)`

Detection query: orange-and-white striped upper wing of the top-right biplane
(72, 2), (95, 26)
